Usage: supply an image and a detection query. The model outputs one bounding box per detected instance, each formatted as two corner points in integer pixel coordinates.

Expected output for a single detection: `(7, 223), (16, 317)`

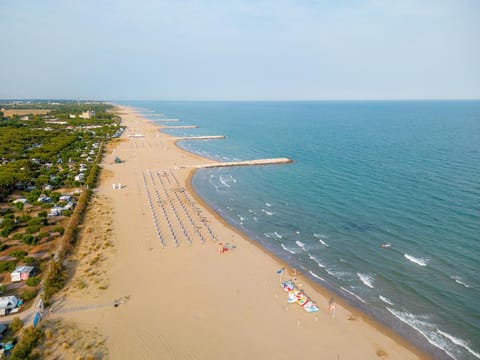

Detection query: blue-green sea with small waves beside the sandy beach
(122, 101), (480, 360)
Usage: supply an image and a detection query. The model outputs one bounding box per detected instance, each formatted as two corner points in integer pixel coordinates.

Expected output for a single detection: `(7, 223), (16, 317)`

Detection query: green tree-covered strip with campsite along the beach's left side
(0, 101), (122, 352)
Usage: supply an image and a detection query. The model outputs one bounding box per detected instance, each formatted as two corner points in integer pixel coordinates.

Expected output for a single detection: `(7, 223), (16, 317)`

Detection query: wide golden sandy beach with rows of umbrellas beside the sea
(50, 108), (425, 359)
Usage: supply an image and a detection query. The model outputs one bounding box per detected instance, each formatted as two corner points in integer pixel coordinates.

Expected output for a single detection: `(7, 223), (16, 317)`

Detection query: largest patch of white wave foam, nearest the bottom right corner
(387, 307), (458, 359)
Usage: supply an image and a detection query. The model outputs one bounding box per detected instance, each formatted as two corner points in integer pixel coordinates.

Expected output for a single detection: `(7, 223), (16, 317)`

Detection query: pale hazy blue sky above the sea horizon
(0, 0), (480, 100)
